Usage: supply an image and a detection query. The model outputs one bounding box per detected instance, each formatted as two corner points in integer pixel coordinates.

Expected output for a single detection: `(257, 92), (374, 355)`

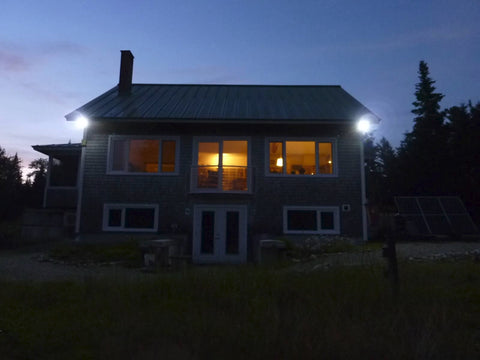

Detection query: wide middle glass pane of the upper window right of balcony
(285, 141), (316, 175)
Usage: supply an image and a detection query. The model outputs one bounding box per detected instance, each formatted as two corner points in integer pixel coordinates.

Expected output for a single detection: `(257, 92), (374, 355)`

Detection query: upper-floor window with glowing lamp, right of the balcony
(268, 140), (336, 175)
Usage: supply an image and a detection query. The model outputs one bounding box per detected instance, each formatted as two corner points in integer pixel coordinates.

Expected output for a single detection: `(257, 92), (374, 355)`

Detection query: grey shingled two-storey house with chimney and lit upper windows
(32, 50), (379, 263)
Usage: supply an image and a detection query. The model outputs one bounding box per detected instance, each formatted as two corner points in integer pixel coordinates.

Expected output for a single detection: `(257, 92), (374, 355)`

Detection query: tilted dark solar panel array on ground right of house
(395, 196), (478, 235)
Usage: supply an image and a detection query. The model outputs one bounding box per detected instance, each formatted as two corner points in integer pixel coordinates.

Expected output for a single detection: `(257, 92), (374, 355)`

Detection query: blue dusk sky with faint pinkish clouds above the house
(0, 0), (480, 174)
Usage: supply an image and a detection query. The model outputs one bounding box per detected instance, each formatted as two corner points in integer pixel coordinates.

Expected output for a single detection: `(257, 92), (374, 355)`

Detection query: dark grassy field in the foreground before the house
(0, 262), (480, 359)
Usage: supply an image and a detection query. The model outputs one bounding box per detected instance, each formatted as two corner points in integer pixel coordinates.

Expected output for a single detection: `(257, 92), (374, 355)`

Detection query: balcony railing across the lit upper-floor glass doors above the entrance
(190, 166), (252, 193)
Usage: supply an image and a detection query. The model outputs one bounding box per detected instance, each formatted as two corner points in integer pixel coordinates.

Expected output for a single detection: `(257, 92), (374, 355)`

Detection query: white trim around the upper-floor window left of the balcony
(107, 135), (180, 176)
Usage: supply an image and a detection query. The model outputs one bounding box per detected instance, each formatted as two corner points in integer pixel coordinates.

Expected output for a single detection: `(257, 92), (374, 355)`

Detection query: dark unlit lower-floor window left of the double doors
(103, 204), (158, 231)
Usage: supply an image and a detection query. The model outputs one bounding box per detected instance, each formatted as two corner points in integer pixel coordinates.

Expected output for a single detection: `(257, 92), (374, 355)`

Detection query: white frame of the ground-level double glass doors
(192, 204), (248, 264)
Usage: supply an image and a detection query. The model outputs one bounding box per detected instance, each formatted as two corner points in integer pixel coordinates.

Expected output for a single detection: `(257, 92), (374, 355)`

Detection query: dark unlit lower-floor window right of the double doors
(283, 206), (340, 234)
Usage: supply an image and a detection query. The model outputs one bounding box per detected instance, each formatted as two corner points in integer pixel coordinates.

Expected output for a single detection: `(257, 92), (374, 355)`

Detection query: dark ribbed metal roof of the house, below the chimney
(65, 84), (379, 122)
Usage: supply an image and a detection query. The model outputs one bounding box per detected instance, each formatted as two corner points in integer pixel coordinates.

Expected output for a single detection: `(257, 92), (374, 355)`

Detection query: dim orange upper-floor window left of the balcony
(108, 136), (178, 174)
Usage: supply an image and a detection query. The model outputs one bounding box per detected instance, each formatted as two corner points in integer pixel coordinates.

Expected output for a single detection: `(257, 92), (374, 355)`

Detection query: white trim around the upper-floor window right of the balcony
(265, 137), (338, 179)
